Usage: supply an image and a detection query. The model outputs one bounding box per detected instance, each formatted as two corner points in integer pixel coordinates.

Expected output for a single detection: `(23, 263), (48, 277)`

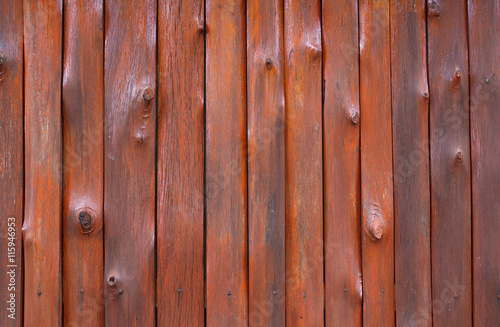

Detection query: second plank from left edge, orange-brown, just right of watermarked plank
(23, 0), (62, 326)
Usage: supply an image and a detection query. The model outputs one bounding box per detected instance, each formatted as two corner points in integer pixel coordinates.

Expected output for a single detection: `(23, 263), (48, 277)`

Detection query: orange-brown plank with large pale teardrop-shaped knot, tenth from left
(359, 0), (394, 326)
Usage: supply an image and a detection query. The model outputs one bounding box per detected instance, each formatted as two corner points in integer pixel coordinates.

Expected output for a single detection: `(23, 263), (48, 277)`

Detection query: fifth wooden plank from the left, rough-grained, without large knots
(157, 0), (205, 327)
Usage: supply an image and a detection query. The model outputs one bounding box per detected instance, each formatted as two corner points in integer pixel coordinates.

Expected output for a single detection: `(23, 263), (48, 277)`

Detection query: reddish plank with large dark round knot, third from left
(62, 0), (104, 326)
